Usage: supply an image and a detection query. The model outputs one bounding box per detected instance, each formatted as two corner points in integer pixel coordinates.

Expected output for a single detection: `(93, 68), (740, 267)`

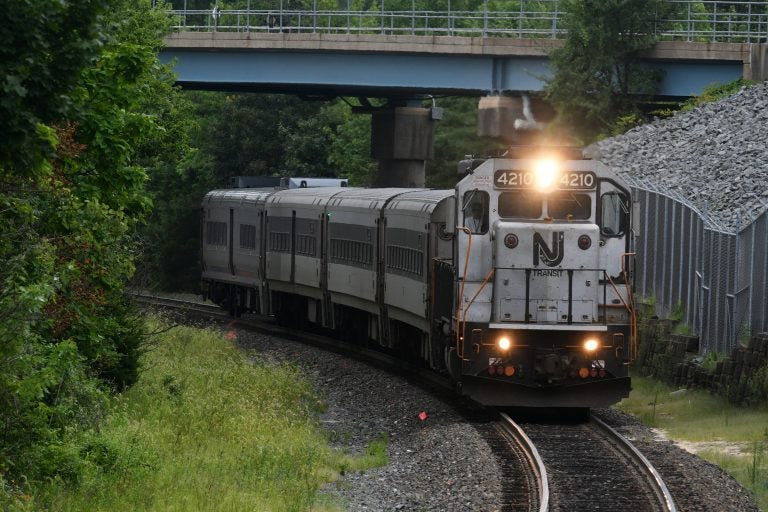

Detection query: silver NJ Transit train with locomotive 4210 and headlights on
(201, 148), (637, 408)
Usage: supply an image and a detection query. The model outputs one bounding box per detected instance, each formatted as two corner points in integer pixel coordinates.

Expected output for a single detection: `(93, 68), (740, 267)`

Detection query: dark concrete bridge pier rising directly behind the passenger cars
(371, 106), (442, 188)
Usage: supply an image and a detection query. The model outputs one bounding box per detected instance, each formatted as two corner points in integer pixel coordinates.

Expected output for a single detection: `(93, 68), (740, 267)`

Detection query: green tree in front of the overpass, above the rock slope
(546, 0), (668, 143)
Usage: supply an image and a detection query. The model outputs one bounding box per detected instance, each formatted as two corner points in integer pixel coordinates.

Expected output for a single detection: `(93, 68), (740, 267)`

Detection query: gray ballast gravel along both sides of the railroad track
(225, 322), (759, 512)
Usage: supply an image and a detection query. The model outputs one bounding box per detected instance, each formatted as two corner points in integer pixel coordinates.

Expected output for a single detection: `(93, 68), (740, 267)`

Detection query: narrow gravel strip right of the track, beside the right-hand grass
(593, 409), (760, 512)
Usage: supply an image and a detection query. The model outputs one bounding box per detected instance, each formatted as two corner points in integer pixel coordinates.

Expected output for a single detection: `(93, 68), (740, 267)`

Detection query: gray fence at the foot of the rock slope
(625, 176), (768, 353)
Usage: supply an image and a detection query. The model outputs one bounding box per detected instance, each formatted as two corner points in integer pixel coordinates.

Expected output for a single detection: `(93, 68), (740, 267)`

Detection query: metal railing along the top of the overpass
(162, 0), (768, 43)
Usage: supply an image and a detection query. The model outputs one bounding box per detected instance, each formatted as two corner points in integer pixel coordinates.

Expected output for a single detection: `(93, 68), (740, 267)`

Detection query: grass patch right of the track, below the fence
(617, 377), (768, 510)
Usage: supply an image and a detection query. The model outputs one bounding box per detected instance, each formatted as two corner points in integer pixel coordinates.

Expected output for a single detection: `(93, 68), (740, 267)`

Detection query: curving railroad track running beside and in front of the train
(133, 294), (677, 512)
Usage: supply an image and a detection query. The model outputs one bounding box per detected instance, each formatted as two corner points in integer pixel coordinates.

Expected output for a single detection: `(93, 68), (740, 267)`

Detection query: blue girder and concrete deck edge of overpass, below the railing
(162, 32), (765, 97)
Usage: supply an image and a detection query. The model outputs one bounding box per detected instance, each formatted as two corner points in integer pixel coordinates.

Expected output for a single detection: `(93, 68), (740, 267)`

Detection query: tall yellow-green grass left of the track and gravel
(27, 318), (387, 511)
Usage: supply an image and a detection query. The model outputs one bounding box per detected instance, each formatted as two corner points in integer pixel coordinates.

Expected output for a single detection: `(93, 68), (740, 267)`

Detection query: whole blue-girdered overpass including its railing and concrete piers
(161, 0), (768, 186)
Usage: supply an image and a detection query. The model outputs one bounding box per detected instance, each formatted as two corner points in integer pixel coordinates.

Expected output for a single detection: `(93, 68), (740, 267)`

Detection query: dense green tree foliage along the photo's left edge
(0, 0), (177, 498)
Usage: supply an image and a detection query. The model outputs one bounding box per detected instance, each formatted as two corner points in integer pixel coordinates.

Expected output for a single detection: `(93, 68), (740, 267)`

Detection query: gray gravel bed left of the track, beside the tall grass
(238, 331), (502, 512)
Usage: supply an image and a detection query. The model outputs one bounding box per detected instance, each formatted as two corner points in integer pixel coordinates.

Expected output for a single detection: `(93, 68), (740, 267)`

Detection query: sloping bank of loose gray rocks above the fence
(587, 83), (768, 231)
